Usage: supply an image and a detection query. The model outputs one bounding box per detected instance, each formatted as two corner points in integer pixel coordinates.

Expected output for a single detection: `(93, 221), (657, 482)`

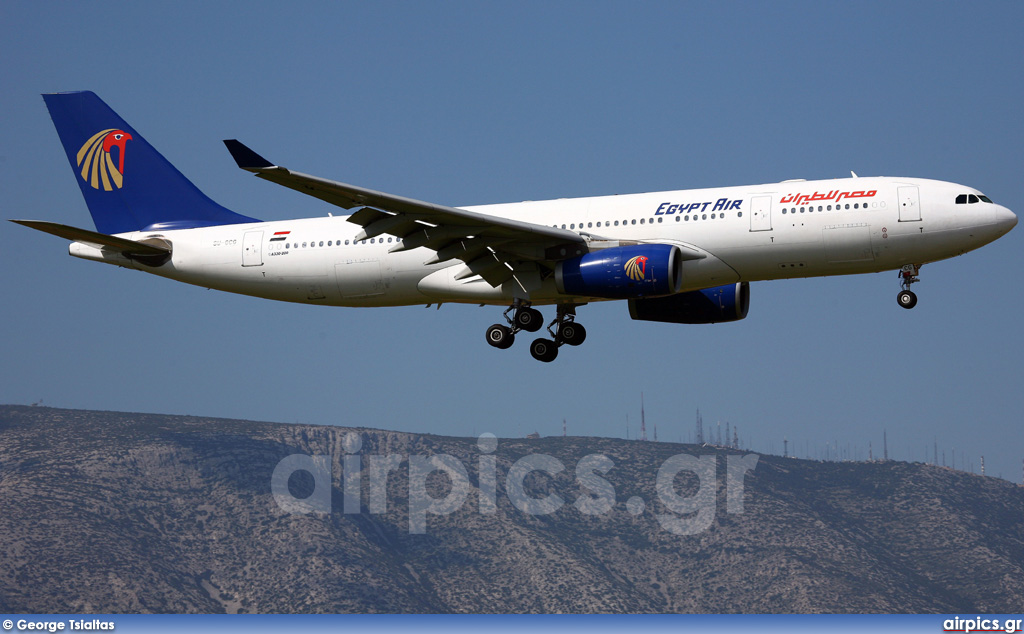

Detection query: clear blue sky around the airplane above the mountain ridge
(0, 2), (1024, 481)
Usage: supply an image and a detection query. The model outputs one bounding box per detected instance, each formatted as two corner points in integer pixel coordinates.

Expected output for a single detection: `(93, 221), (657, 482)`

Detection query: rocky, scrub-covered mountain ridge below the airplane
(0, 406), (1024, 614)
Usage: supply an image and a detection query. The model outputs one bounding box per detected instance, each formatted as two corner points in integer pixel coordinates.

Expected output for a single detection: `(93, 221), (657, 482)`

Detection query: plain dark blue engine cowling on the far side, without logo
(630, 282), (751, 324)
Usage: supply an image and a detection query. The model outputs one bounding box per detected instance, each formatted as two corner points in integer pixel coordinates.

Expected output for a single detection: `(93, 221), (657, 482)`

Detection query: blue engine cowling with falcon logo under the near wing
(555, 245), (683, 299)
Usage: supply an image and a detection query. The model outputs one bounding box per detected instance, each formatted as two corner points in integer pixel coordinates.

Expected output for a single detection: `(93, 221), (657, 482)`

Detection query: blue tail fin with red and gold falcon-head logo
(43, 92), (258, 234)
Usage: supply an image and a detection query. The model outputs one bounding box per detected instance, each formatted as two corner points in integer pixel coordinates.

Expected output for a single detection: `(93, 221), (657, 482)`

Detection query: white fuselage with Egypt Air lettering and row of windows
(71, 177), (1016, 306)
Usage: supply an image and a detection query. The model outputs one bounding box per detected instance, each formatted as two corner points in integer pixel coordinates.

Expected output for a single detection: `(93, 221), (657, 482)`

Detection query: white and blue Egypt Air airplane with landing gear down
(12, 91), (1017, 362)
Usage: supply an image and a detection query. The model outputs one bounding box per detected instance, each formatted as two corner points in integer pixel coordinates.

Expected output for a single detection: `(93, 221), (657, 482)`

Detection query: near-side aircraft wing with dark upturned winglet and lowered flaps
(224, 140), (587, 291)
